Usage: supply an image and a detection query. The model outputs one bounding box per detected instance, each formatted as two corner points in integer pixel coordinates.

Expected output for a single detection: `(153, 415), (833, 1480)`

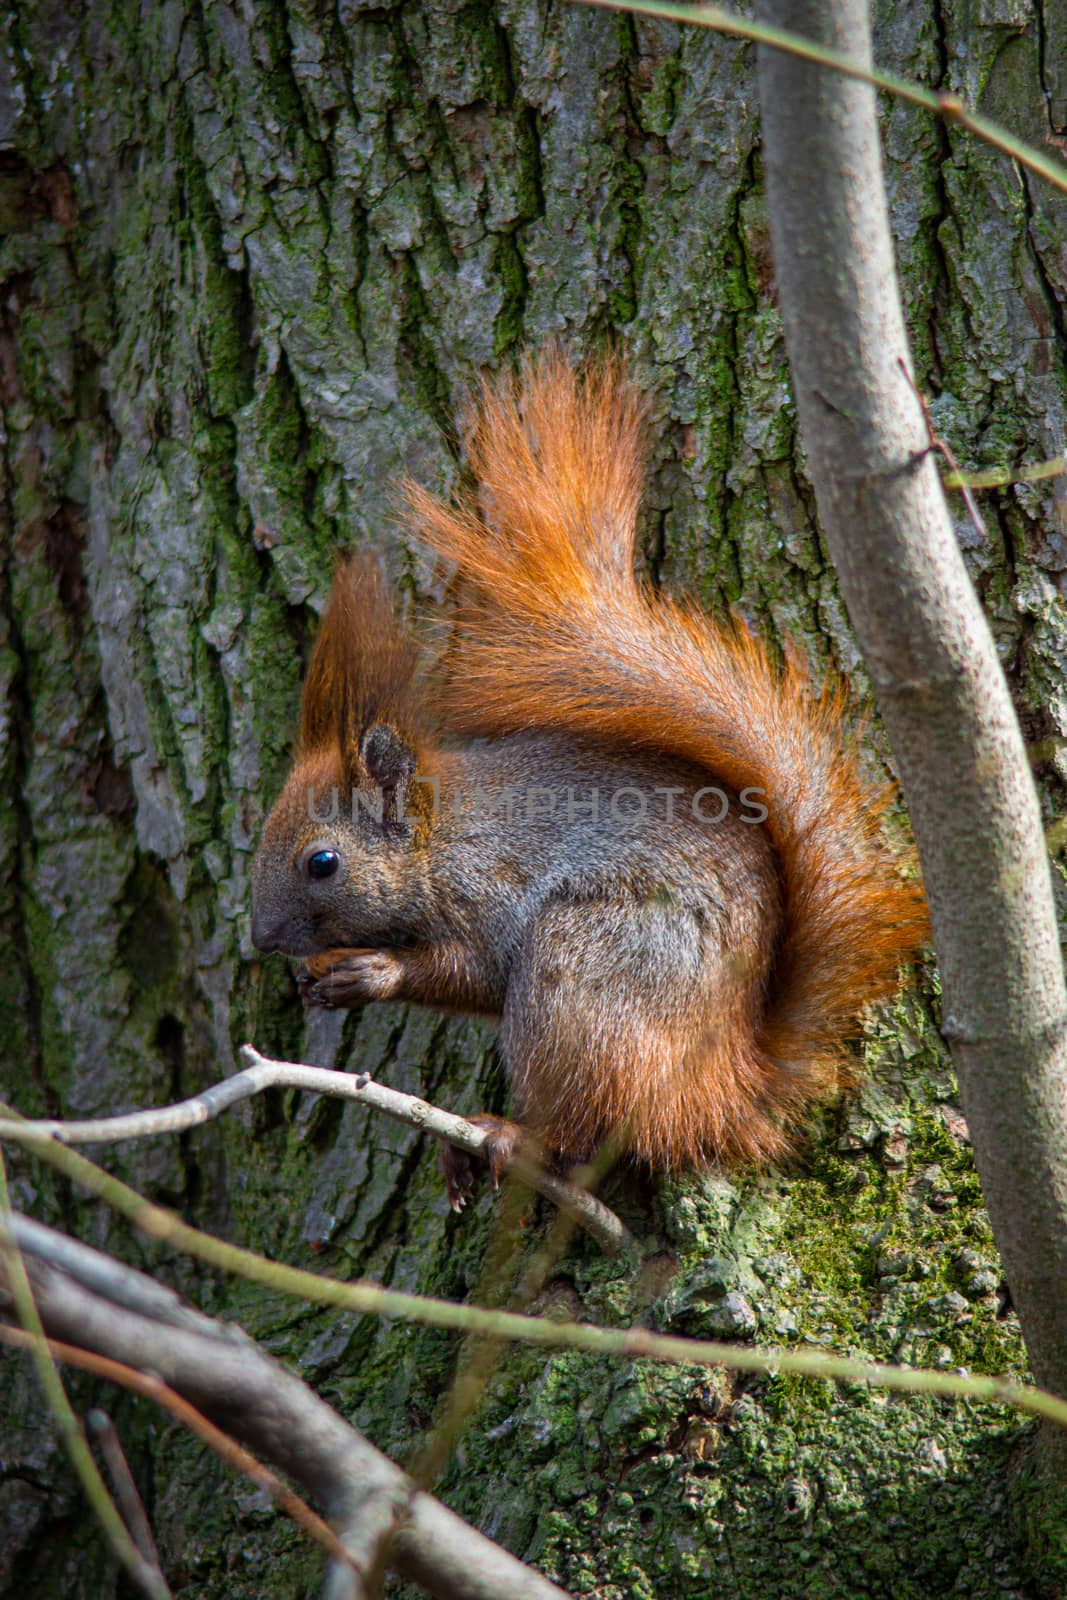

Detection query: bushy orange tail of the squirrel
(408, 352), (926, 1098)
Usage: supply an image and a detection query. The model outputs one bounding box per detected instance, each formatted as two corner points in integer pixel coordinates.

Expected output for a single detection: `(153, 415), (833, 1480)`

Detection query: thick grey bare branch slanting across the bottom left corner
(0, 1219), (566, 1600)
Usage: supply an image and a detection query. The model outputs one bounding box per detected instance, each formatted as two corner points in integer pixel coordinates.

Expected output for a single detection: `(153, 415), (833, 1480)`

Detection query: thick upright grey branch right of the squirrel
(760, 0), (1067, 1395)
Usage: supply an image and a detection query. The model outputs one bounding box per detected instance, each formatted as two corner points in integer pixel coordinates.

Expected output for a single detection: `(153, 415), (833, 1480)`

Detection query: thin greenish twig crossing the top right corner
(579, 0), (1067, 194)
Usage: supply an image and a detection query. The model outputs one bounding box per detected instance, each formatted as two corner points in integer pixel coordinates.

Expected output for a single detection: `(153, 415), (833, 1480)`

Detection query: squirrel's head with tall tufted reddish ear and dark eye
(253, 560), (434, 957)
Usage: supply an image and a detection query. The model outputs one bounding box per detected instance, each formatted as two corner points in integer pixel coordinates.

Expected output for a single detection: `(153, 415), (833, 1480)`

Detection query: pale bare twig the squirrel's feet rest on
(0, 1045), (632, 1256)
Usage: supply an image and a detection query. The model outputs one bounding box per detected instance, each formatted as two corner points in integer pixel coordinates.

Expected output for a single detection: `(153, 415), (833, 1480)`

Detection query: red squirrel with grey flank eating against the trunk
(253, 349), (928, 1205)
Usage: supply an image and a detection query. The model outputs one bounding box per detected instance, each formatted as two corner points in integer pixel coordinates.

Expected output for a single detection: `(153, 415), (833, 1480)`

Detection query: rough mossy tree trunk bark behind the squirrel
(0, 0), (1067, 1600)
